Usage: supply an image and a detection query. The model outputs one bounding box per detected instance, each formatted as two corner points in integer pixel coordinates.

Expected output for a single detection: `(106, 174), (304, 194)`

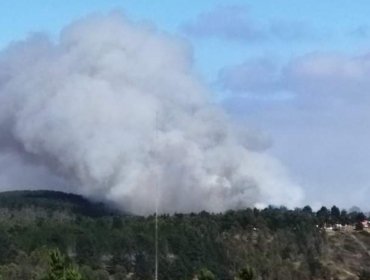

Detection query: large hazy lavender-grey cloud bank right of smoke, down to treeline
(220, 50), (370, 208)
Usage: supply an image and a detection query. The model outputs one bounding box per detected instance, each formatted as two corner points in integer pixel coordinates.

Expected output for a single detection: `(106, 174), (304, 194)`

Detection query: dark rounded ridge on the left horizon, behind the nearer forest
(0, 190), (120, 217)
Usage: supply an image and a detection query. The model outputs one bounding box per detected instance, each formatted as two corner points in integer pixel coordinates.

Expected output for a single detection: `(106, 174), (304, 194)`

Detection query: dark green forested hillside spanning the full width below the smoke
(0, 191), (370, 280)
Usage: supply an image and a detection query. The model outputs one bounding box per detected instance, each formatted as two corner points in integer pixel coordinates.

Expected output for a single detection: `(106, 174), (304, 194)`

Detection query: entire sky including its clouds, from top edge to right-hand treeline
(0, 0), (370, 207)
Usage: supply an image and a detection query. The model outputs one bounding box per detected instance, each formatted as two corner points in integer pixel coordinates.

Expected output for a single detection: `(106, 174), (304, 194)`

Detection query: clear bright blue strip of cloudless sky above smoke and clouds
(0, 0), (370, 81)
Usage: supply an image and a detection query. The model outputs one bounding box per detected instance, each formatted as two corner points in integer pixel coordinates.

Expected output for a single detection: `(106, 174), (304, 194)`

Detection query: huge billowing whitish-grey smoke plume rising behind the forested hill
(0, 14), (302, 214)
